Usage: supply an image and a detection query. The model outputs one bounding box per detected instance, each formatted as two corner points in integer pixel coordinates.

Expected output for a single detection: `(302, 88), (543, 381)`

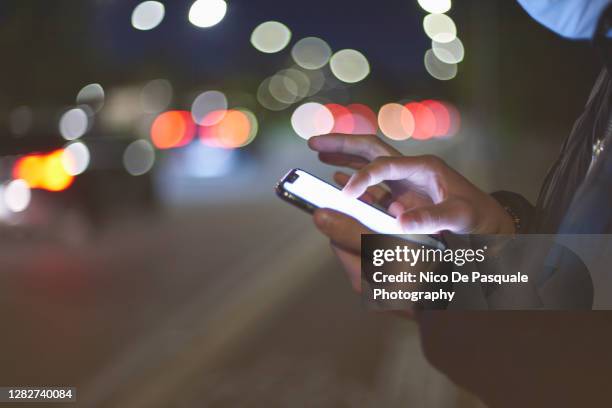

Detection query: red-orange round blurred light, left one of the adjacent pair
(151, 111), (195, 149)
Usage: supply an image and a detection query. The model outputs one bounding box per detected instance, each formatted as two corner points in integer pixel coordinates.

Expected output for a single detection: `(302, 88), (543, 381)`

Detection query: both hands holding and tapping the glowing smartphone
(308, 134), (514, 291)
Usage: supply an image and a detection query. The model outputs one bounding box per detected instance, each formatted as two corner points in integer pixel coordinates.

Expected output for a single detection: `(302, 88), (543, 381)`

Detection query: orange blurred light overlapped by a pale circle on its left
(199, 109), (253, 149)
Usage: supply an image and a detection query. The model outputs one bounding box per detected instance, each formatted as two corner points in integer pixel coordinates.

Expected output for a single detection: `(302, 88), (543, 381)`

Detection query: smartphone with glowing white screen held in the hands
(276, 169), (446, 249)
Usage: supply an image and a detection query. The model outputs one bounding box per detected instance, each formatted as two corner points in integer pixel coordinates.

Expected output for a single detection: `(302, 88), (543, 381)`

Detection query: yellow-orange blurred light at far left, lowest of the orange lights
(13, 149), (74, 191)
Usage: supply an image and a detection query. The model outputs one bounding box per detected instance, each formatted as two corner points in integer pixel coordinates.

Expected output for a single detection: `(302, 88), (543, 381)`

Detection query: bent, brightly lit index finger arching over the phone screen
(343, 156), (446, 203)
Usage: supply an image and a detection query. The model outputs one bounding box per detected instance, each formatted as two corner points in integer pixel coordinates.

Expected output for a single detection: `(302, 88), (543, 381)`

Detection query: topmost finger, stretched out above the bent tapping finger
(308, 134), (400, 161)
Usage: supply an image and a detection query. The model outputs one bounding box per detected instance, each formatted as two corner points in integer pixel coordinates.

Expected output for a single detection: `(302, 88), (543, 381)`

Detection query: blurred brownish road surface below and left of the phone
(0, 201), (482, 408)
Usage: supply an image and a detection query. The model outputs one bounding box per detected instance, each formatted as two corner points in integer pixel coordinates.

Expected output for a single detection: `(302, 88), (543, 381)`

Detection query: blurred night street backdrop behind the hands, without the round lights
(0, 0), (601, 408)
